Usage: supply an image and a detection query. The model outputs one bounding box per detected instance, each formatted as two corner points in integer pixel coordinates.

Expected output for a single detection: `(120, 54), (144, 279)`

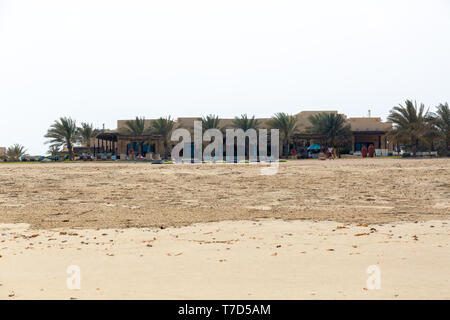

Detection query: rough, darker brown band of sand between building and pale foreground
(0, 159), (450, 229)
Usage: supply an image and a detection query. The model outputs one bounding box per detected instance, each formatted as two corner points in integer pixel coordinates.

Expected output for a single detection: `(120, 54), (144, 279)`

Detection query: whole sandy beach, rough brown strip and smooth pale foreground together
(0, 159), (450, 299)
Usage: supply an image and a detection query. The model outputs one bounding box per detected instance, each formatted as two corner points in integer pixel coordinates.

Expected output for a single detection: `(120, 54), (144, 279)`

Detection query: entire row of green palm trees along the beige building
(2, 100), (450, 160)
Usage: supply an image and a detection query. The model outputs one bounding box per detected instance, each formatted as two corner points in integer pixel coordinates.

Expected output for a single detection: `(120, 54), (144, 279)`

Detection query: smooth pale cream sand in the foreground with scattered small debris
(0, 220), (450, 299)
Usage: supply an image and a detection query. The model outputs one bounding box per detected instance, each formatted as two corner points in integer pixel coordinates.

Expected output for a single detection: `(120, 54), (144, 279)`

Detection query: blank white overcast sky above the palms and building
(0, 0), (450, 154)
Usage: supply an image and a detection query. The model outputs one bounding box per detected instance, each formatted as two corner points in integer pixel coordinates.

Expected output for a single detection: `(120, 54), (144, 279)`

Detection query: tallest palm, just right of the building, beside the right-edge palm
(387, 100), (432, 155)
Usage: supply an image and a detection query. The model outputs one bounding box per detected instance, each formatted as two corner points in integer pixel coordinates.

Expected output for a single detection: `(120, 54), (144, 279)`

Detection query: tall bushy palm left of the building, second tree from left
(45, 117), (80, 160)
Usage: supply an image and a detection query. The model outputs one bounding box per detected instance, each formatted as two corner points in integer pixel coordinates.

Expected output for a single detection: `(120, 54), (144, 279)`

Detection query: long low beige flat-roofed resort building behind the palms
(89, 111), (393, 157)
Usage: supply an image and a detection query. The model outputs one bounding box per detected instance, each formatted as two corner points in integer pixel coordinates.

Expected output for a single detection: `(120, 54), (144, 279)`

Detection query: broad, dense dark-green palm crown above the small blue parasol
(308, 112), (352, 147)
